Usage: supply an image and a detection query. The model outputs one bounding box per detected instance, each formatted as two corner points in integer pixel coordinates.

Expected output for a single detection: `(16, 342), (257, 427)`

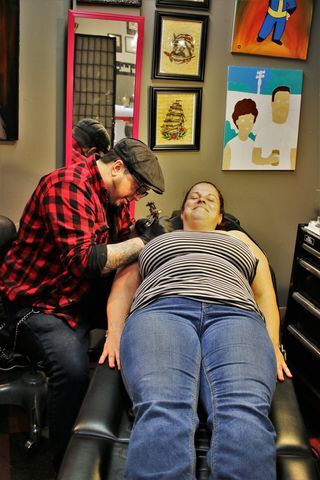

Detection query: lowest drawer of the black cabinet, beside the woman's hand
(284, 325), (320, 402)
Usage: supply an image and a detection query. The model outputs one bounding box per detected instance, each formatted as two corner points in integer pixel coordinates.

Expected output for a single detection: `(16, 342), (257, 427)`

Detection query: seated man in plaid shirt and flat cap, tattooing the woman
(0, 138), (164, 469)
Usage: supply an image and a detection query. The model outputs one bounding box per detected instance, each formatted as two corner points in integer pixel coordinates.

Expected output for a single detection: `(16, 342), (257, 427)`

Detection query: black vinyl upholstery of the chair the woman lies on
(58, 212), (320, 480)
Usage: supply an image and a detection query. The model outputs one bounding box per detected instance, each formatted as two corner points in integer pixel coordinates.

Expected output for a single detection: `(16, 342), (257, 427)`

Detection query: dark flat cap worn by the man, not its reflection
(113, 138), (164, 193)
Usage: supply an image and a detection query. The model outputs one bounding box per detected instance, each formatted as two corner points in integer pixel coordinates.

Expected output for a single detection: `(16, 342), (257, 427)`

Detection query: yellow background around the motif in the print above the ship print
(160, 19), (202, 75)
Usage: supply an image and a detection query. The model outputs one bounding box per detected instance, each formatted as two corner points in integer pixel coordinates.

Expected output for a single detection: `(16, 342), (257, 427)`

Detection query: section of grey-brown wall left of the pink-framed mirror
(0, 0), (69, 221)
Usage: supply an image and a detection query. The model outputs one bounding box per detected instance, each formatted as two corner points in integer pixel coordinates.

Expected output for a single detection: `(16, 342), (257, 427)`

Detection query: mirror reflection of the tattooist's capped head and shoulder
(71, 118), (110, 163)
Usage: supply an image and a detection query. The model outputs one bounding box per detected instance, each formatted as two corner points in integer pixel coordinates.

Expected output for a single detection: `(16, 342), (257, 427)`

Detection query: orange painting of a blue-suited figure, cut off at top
(231, 0), (313, 60)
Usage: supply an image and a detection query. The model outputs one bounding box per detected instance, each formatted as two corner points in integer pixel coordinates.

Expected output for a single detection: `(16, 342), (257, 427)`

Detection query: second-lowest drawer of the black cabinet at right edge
(286, 290), (320, 349)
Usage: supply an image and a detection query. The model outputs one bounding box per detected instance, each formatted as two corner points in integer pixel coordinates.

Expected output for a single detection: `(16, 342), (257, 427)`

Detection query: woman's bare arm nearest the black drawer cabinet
(230, 231), (292, 381)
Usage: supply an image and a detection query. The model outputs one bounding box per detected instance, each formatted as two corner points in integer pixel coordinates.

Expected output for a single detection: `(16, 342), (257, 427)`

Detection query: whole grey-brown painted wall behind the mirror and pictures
(0, 0), (320, 305)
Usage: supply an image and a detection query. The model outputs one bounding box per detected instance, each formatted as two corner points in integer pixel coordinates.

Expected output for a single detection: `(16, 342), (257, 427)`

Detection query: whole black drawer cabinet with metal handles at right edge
(283, 224), (320, 423)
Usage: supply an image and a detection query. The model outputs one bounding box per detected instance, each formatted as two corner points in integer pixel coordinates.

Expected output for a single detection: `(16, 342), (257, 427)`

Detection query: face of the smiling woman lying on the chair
(181, 183), (222, 230)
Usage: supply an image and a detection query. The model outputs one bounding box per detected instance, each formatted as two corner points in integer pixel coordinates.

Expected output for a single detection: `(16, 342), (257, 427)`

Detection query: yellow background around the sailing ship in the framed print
(156, 92), (196, 145)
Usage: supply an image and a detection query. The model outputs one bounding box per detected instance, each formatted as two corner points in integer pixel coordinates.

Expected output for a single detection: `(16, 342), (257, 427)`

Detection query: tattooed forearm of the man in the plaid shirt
(102, 238), (143, 274)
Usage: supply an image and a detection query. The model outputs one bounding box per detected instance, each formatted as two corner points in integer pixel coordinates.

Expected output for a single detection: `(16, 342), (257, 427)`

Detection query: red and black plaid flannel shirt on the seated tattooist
(0, 159), (132, 327)
